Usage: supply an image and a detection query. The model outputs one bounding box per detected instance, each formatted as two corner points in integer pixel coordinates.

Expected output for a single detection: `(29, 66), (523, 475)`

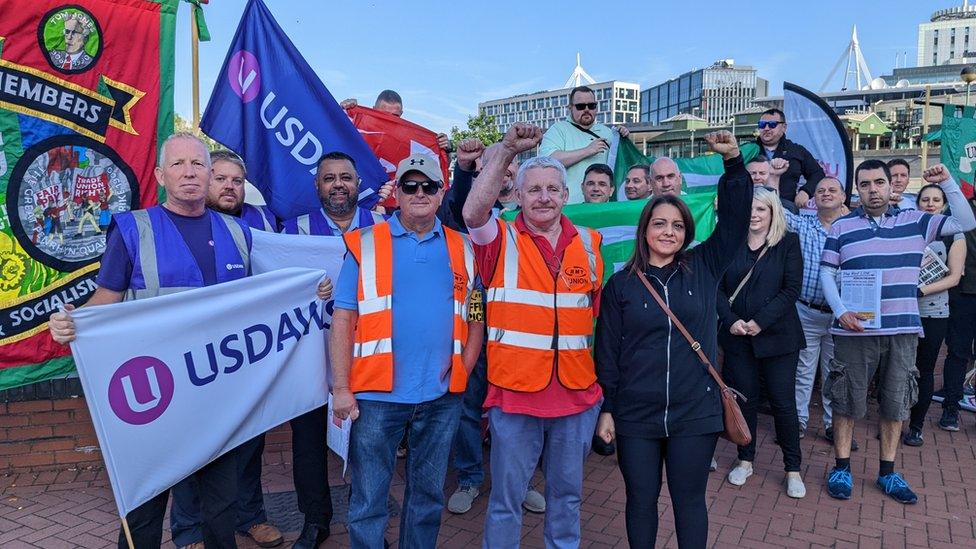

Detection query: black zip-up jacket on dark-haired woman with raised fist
(595, 157), (752, 438)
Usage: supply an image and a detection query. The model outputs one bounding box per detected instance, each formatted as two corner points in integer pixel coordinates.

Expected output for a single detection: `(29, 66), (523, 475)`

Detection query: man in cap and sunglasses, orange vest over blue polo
(329, 154), (484, 548)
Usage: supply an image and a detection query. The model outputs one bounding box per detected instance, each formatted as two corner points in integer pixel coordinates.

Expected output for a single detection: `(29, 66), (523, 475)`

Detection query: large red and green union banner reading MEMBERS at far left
(0, 0), (179, 390)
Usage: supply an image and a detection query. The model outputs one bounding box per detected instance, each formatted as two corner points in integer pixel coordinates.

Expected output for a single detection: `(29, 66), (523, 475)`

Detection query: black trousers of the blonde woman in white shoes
(722, 341), (800, 472)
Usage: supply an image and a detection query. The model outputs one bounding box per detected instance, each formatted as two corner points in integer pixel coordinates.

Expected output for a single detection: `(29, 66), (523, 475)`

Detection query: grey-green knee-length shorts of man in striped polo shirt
(823, 334), (918, 421)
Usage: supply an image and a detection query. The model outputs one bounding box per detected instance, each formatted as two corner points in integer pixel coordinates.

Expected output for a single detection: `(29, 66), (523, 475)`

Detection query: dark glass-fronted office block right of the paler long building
(640, 59), (769, 125)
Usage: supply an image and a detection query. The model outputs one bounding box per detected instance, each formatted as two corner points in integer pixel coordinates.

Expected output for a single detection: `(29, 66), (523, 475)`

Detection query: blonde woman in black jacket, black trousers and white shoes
(718, 187), (806, 498)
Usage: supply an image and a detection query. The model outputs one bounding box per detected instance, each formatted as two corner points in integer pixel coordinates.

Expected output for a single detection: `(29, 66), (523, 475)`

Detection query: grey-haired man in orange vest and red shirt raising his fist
(463, 124), (603, 548)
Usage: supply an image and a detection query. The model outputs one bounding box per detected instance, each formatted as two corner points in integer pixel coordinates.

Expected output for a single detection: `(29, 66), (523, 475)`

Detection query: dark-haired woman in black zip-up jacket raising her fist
(595, 132), (752, 548)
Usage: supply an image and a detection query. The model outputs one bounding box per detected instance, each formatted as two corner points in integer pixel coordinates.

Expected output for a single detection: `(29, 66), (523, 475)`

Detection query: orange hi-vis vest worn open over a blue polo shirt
(343, 222), (475, 393)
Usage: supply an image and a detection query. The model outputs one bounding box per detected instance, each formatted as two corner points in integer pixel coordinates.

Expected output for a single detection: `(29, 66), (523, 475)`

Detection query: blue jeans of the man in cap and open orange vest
(349, 393), (461, 549)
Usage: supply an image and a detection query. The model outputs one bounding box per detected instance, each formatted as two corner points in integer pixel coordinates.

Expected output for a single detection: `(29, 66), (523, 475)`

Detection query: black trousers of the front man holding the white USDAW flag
(119, 450), (237, 549)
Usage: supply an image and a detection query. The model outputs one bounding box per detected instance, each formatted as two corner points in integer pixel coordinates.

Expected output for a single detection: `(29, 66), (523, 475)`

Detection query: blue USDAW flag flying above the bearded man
(200, 0), (389, 219)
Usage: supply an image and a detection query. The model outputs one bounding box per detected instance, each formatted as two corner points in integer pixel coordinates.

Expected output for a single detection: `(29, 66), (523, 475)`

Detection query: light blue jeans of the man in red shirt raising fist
(483, 403), (601, 549)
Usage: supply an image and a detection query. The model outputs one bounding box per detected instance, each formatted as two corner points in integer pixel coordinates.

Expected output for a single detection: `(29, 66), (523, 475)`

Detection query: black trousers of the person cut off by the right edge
(940, 292), (976, 410)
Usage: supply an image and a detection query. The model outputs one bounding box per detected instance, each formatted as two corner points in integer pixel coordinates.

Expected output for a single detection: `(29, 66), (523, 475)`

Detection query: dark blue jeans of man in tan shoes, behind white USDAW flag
(169, 434), (268, 547)
